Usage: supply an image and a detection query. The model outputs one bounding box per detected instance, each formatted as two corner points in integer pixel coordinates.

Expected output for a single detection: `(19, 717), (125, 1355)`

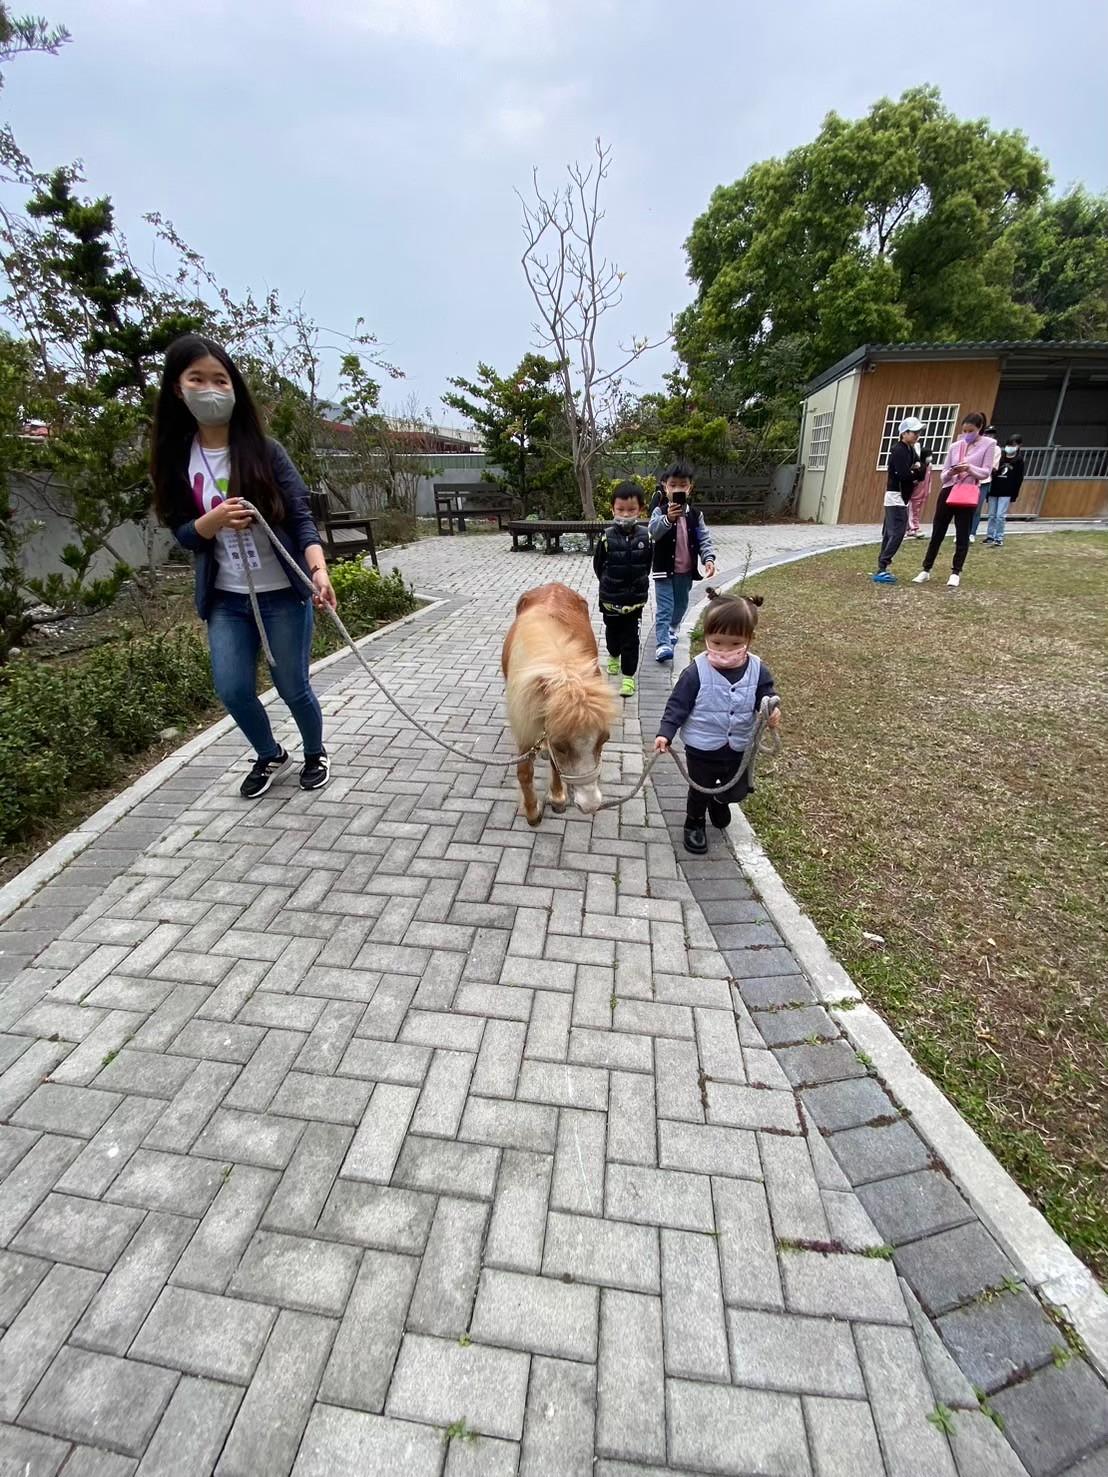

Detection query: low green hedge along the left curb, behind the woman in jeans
(0, 561), (415, 842)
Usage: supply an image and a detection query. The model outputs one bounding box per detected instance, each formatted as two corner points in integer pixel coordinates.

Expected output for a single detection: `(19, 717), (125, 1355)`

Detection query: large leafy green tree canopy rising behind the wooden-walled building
(678, 87), (1104, 424)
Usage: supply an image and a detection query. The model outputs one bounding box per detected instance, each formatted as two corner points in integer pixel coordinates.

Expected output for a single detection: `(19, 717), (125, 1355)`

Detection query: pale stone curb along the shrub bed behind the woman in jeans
(0, 591), (449, 923)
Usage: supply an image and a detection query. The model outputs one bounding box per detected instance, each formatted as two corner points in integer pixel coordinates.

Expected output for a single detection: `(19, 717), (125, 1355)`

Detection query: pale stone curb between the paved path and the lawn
(685, 543), (1108, 1378)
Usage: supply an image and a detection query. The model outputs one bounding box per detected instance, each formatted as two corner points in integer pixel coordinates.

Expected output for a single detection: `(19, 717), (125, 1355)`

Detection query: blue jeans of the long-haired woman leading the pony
(208, 589), (324, 759)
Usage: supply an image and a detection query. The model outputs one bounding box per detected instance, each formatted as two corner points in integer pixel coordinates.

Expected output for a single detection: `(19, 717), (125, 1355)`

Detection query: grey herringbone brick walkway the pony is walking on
(0, 527), (1101, 1477)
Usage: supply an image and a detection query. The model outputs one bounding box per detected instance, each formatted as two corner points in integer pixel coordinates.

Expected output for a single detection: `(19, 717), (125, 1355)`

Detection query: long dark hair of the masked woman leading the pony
(151, 334), (285, 526)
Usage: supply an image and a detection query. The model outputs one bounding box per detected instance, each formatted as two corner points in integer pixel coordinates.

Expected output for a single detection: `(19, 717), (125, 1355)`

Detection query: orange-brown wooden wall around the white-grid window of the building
(838, 359), (1000, 523)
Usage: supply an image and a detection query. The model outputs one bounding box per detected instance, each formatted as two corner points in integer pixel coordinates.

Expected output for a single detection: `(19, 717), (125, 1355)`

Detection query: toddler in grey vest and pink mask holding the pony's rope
(654, 589), (782, 855)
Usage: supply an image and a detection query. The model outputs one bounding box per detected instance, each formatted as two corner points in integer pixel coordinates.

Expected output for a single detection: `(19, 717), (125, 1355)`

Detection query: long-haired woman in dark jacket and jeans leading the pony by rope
(151, 334), (337, 801)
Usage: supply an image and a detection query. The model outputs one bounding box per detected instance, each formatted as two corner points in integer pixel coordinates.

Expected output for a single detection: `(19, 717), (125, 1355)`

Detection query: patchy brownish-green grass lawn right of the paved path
(729, 532), (1108, 1281)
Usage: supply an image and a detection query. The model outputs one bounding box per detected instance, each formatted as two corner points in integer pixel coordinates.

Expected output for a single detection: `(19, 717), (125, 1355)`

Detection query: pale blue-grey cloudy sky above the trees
(8, 0), (1108, 418)
